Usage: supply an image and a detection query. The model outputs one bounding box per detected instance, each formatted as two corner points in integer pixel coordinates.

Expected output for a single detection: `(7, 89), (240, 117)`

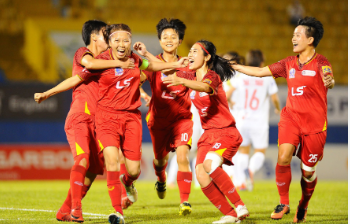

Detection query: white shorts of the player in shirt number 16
(237, 122), (269, 149)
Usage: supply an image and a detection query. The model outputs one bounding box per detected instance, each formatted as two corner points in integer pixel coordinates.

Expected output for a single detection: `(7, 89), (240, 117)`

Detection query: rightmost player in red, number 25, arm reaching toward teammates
(234, 17), (334, 222)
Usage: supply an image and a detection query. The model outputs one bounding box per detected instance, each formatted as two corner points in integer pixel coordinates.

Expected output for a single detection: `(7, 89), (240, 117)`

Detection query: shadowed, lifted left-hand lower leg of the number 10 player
(153, 154), (169, 199)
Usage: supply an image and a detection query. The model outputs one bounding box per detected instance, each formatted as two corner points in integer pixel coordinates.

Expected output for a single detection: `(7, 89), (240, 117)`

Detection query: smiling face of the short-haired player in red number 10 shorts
(159, 28), (181, 53)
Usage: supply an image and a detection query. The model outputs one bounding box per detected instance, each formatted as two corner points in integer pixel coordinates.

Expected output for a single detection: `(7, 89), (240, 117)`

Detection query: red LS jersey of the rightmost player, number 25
(268, 54), (333, 134)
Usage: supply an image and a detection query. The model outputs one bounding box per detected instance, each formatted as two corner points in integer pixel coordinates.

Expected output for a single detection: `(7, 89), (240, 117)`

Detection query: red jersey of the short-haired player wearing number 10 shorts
(144, 54), (192, 129)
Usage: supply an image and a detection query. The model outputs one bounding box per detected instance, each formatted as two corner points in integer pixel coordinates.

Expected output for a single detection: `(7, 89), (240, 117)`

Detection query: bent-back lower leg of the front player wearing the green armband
(120, 158), (141, 203)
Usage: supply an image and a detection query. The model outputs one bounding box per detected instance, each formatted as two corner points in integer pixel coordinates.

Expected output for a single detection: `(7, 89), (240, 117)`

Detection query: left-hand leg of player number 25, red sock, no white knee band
(271, 143), (295, 219)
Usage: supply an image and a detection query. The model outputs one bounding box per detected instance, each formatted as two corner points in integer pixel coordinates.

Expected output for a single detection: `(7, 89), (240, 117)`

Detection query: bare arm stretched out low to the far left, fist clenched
(34, 75), (83, 103)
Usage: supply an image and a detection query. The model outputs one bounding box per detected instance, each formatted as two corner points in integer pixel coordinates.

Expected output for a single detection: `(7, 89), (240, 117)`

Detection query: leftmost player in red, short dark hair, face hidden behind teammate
(34, 20), (134, 222)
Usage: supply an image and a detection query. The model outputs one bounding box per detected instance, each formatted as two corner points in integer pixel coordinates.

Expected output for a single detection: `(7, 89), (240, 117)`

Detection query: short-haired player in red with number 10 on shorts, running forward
(135, 18), (193, 215)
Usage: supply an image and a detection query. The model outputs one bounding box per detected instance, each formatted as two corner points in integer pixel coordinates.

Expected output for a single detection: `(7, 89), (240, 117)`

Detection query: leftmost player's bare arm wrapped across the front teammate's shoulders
(80, 54), (135, 70)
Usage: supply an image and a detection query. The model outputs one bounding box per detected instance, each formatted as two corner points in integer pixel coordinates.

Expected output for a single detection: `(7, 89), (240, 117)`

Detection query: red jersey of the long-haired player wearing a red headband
(177, 70), (236, 130)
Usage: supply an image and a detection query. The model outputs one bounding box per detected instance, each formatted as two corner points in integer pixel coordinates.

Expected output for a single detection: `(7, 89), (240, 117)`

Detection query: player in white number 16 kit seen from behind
(226, 50), (280, 190)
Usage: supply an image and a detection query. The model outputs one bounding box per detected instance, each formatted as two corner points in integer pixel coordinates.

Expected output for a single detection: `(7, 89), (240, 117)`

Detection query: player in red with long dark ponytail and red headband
(163, 40), (249, 223)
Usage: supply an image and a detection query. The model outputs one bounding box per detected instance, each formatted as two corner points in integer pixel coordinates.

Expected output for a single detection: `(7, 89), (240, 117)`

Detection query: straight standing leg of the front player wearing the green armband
(103, 146), (123, 224)
